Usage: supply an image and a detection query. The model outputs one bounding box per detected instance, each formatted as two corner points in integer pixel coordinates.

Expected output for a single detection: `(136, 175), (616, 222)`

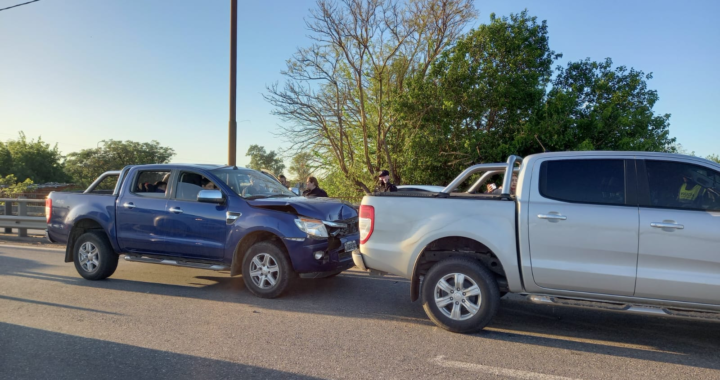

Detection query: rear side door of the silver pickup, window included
(528, 158), (639, 296)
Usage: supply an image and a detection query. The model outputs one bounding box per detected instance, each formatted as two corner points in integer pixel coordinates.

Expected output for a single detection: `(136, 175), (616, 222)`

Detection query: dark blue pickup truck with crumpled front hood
(46, 164), (359, 298)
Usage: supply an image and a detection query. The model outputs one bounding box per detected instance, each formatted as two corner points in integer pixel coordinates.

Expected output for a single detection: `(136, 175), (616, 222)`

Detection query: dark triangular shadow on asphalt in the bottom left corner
(0, 322), (317, 380)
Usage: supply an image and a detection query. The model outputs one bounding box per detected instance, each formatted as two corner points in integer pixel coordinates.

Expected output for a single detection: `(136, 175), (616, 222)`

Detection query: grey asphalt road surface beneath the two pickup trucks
(0, 246), (720, 380)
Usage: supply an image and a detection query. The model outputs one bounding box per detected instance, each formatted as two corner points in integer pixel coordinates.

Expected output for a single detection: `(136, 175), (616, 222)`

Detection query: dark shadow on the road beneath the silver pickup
(474, 300), (720, 370)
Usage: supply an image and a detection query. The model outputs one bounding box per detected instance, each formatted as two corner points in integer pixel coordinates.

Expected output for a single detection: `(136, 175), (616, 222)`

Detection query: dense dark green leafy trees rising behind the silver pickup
(397, 11), (676, 185)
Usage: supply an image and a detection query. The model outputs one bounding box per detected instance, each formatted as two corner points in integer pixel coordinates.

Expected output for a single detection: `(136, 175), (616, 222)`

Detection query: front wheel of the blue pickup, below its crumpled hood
(242, 241), (297, 298)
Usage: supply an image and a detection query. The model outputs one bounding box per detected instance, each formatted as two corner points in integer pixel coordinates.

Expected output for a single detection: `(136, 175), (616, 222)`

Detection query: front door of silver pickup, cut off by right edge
(635, 159), (720, 305)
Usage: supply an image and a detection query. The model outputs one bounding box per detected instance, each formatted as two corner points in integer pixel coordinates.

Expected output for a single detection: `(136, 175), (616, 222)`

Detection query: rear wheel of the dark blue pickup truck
(73, 231), (120, 281)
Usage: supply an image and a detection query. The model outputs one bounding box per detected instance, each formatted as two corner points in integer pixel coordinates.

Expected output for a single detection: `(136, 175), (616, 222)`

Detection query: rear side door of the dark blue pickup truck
(116, 170), (176, 254)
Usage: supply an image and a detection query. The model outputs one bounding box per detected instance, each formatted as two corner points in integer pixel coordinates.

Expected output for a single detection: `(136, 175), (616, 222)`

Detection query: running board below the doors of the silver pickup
(528, 294), (720, 322)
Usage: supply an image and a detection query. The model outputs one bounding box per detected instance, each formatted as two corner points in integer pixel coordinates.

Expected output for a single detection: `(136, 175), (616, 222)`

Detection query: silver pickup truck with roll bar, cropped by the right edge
(353, 152), (720, 332)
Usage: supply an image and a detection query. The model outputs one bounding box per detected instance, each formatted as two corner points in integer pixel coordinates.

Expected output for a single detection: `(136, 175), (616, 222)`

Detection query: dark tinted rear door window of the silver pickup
(540, 159), (625, 205)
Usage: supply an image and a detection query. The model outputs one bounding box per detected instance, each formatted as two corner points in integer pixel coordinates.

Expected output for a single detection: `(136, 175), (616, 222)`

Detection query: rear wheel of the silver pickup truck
(422, 257), (500, 333)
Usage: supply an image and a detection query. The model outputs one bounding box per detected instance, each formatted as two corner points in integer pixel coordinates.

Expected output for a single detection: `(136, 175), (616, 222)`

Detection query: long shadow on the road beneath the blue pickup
(0, 254), (432, 326)
